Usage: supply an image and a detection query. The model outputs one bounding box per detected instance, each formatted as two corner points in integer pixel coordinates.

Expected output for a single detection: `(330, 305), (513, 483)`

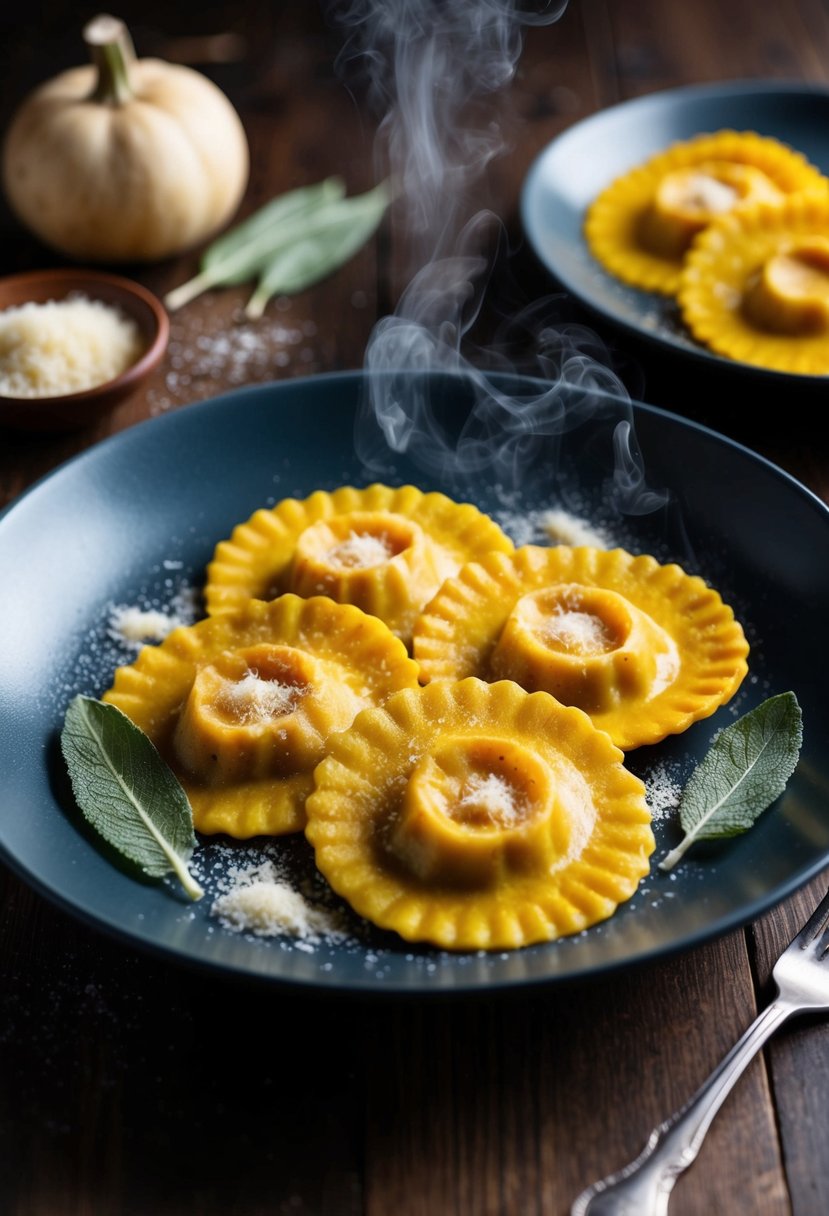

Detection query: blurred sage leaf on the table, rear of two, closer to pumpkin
(164, 178), (345, 313)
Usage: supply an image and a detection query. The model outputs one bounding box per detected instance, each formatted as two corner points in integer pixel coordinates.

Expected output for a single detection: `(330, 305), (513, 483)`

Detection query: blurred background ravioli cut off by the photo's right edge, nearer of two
(677, 195), (829, 376)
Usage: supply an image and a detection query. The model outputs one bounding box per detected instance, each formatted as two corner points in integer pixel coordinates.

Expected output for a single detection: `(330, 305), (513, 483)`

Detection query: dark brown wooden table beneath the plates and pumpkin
(0, 0), (829, 1216)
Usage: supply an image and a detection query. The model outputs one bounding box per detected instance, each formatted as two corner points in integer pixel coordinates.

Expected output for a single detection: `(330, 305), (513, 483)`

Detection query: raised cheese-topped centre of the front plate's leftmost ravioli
(173, 643), (360, 786)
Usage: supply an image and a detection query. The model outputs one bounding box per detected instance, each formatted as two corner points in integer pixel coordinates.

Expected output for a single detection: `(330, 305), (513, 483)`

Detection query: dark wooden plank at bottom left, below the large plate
(0, 869), (362, 1216)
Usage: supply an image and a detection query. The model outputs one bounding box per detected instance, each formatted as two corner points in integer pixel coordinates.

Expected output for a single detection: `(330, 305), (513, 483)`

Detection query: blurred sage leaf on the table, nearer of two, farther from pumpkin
(244, 182), (390, 320)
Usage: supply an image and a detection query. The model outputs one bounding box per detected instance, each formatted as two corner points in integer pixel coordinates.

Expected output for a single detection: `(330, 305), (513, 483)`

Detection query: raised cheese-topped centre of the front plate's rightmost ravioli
(490, 584), (679, 714)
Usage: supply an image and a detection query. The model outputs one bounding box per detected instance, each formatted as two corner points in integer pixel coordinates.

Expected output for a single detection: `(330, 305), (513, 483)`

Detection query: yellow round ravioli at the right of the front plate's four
(413, 545), (749, 750)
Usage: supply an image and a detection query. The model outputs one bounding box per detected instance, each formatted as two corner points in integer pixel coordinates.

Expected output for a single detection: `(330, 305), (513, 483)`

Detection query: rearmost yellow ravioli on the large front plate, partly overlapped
(205, 484), (514, 643)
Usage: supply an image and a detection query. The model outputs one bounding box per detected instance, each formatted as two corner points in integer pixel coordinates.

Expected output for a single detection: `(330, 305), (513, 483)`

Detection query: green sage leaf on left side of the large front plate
(61, 694), (204, 900)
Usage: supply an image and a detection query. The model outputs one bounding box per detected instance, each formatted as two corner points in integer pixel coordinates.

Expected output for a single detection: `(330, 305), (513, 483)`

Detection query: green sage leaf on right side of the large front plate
(659, 692), (803, 869)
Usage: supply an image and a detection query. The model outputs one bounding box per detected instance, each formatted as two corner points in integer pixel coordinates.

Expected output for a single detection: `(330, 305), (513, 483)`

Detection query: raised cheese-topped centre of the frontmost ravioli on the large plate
(389, 736), (573, 888)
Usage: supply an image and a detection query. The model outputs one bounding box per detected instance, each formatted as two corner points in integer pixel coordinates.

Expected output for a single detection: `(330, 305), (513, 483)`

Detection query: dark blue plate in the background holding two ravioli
(521, 80), (829, 387)
